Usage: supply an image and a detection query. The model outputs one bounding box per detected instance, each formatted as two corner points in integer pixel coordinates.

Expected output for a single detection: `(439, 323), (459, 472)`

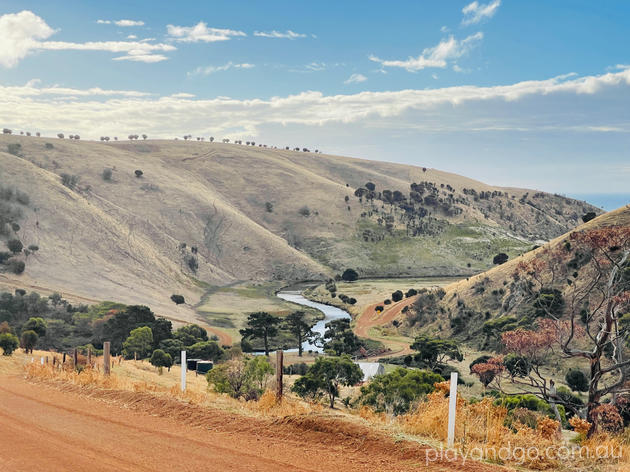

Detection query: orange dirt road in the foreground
(0, 376), (496, 472)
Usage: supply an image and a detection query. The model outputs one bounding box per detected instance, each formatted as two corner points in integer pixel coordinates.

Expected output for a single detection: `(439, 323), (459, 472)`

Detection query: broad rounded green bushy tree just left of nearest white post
(359, 367), (444, 415)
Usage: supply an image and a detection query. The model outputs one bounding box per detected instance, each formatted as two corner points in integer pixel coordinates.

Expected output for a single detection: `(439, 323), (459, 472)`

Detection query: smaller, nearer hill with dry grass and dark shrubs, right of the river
(399, 205), (630, 349)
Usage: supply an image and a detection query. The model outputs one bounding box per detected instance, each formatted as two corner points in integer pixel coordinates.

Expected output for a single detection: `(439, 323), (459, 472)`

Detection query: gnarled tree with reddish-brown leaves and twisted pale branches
(503, 226), (630, 437)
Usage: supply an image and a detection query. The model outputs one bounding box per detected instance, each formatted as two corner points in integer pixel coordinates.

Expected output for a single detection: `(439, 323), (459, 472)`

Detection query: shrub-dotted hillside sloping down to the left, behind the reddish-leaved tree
(399, 205), (630, 349)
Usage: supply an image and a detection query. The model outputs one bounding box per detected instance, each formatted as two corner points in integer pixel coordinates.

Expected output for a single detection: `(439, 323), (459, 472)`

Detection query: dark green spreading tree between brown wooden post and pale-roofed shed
(292, 355), (363, 408)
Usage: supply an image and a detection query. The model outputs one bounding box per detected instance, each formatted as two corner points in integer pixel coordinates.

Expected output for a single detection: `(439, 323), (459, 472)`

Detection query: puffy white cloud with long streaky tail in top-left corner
(0, 10), (177, 67)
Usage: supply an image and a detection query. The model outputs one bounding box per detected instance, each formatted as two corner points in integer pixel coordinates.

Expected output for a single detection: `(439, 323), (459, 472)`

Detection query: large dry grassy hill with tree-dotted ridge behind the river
(0, 135), (600, 319)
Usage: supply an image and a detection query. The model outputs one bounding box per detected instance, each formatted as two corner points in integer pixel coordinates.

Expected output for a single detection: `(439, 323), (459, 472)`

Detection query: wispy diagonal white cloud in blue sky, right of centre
(370, 32), (483, 72)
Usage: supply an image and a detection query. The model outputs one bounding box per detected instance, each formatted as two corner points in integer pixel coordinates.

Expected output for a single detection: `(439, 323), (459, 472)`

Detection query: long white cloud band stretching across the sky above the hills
(0, 69), (630, 138)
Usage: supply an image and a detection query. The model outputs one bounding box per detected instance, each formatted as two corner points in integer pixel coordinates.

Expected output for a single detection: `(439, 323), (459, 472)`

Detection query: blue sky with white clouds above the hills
(0, 0), (630, 206)
